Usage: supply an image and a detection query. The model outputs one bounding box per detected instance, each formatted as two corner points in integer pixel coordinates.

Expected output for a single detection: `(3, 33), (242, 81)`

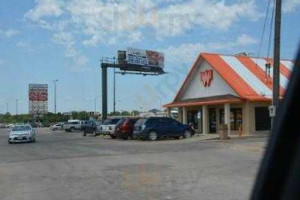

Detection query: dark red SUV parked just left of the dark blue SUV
(114, 118), (139, 140)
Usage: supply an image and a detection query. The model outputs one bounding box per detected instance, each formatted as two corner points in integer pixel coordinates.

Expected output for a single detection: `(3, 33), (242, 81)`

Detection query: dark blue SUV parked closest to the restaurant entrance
(133, 117), (195, 141)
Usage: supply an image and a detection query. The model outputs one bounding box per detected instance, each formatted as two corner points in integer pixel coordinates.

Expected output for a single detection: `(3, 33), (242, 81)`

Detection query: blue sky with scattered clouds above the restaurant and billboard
(0, 0), (300, 113)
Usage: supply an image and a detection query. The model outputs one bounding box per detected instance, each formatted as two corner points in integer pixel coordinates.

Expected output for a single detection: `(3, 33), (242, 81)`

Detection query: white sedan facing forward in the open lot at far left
(8, 124), (35, 144)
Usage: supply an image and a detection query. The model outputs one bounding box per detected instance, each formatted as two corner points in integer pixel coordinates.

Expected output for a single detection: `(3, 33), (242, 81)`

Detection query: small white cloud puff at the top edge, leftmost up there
(25, 0), (63, 21)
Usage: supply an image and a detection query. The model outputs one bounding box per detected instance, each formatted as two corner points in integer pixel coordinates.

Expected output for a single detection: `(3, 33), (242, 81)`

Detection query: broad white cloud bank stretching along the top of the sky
(25, 0), (261, 46)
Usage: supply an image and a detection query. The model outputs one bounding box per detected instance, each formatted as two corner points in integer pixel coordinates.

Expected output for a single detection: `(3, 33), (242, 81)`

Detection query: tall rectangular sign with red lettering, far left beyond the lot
(28, 84), (48, 115)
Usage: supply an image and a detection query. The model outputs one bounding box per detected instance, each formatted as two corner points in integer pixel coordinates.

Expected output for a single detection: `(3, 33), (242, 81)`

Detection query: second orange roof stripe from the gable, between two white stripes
(236, 56), (285, 95)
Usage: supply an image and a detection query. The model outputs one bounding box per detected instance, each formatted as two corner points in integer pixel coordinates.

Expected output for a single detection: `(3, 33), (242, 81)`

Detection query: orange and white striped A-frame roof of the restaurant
(173, 53), (294, 102)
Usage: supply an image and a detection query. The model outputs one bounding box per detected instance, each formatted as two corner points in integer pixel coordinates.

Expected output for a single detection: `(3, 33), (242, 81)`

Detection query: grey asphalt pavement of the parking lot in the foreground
(0, 129), (266, 200)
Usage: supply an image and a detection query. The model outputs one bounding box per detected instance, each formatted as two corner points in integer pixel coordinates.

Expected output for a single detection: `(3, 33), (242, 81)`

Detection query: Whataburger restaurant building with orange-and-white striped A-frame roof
(164, 53), (294, 135)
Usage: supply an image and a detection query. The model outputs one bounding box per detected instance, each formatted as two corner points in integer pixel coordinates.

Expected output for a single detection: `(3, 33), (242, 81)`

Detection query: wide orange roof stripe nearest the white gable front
(202, 54), (260, 99)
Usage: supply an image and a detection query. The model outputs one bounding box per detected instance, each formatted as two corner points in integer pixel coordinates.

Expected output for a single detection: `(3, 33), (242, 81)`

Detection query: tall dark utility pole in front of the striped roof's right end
(272, 0), (282, 130)
